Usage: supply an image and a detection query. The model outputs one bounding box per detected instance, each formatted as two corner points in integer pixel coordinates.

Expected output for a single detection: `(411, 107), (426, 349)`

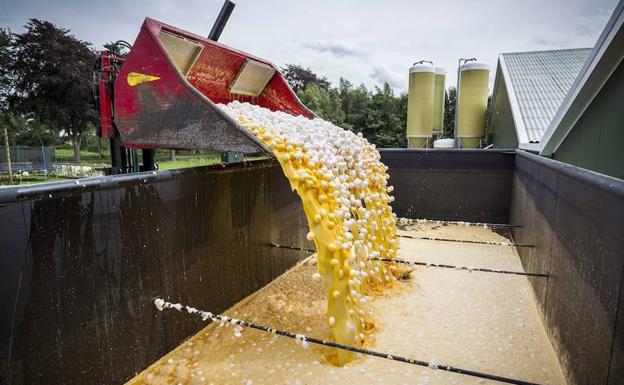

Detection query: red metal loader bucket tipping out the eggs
(114, 18), (314, 153)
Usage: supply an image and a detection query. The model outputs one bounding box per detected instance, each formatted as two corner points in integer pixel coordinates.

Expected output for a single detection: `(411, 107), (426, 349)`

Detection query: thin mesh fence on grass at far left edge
(0, 146), (56, 173)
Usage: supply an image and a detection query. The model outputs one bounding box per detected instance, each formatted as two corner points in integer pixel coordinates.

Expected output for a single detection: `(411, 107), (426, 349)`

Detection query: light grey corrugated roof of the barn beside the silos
(501, 48), (591, 143)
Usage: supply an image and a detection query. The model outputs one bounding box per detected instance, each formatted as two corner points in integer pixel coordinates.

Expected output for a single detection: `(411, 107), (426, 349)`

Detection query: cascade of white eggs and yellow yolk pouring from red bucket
(219, 101), (399, 365)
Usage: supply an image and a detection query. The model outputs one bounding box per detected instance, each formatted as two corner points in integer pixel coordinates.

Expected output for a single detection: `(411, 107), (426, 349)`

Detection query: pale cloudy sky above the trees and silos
(0, 0), (617, 92)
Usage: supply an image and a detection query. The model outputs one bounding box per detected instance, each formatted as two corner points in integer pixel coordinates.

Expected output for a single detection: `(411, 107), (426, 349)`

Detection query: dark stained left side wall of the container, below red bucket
(0, 161), (306, 384)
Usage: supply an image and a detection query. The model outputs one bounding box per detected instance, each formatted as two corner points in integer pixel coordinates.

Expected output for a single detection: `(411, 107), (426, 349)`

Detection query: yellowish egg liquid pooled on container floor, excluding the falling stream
(129, 220), (565, 385)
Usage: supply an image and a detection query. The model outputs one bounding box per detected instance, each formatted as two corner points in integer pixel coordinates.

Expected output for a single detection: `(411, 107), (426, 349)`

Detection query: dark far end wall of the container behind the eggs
(380, 149), (514, 223)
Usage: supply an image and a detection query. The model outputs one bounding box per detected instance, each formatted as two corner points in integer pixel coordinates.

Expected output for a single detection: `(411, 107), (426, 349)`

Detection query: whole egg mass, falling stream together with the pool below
(129, 102), (565, 385)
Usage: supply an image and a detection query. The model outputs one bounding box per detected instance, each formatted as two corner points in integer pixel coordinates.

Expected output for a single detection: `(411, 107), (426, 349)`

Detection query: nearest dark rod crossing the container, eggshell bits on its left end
(154, 298), (539, 385)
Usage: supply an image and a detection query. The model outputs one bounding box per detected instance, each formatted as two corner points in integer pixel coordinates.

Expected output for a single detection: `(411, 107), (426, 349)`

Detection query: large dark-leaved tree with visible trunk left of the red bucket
(9, 19), (97, 162)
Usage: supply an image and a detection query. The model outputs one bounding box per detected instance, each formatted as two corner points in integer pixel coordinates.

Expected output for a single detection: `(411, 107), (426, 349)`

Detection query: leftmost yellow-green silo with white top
(406, 64), (435, 148)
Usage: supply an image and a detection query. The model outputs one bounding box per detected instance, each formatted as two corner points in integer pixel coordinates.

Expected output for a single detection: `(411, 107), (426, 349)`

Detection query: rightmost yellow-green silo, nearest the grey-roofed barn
(456, 62), (490, 148)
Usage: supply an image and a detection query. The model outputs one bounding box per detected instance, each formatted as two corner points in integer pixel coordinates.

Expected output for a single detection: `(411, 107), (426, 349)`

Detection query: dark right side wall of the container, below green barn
(510, 151), (624, 385)
